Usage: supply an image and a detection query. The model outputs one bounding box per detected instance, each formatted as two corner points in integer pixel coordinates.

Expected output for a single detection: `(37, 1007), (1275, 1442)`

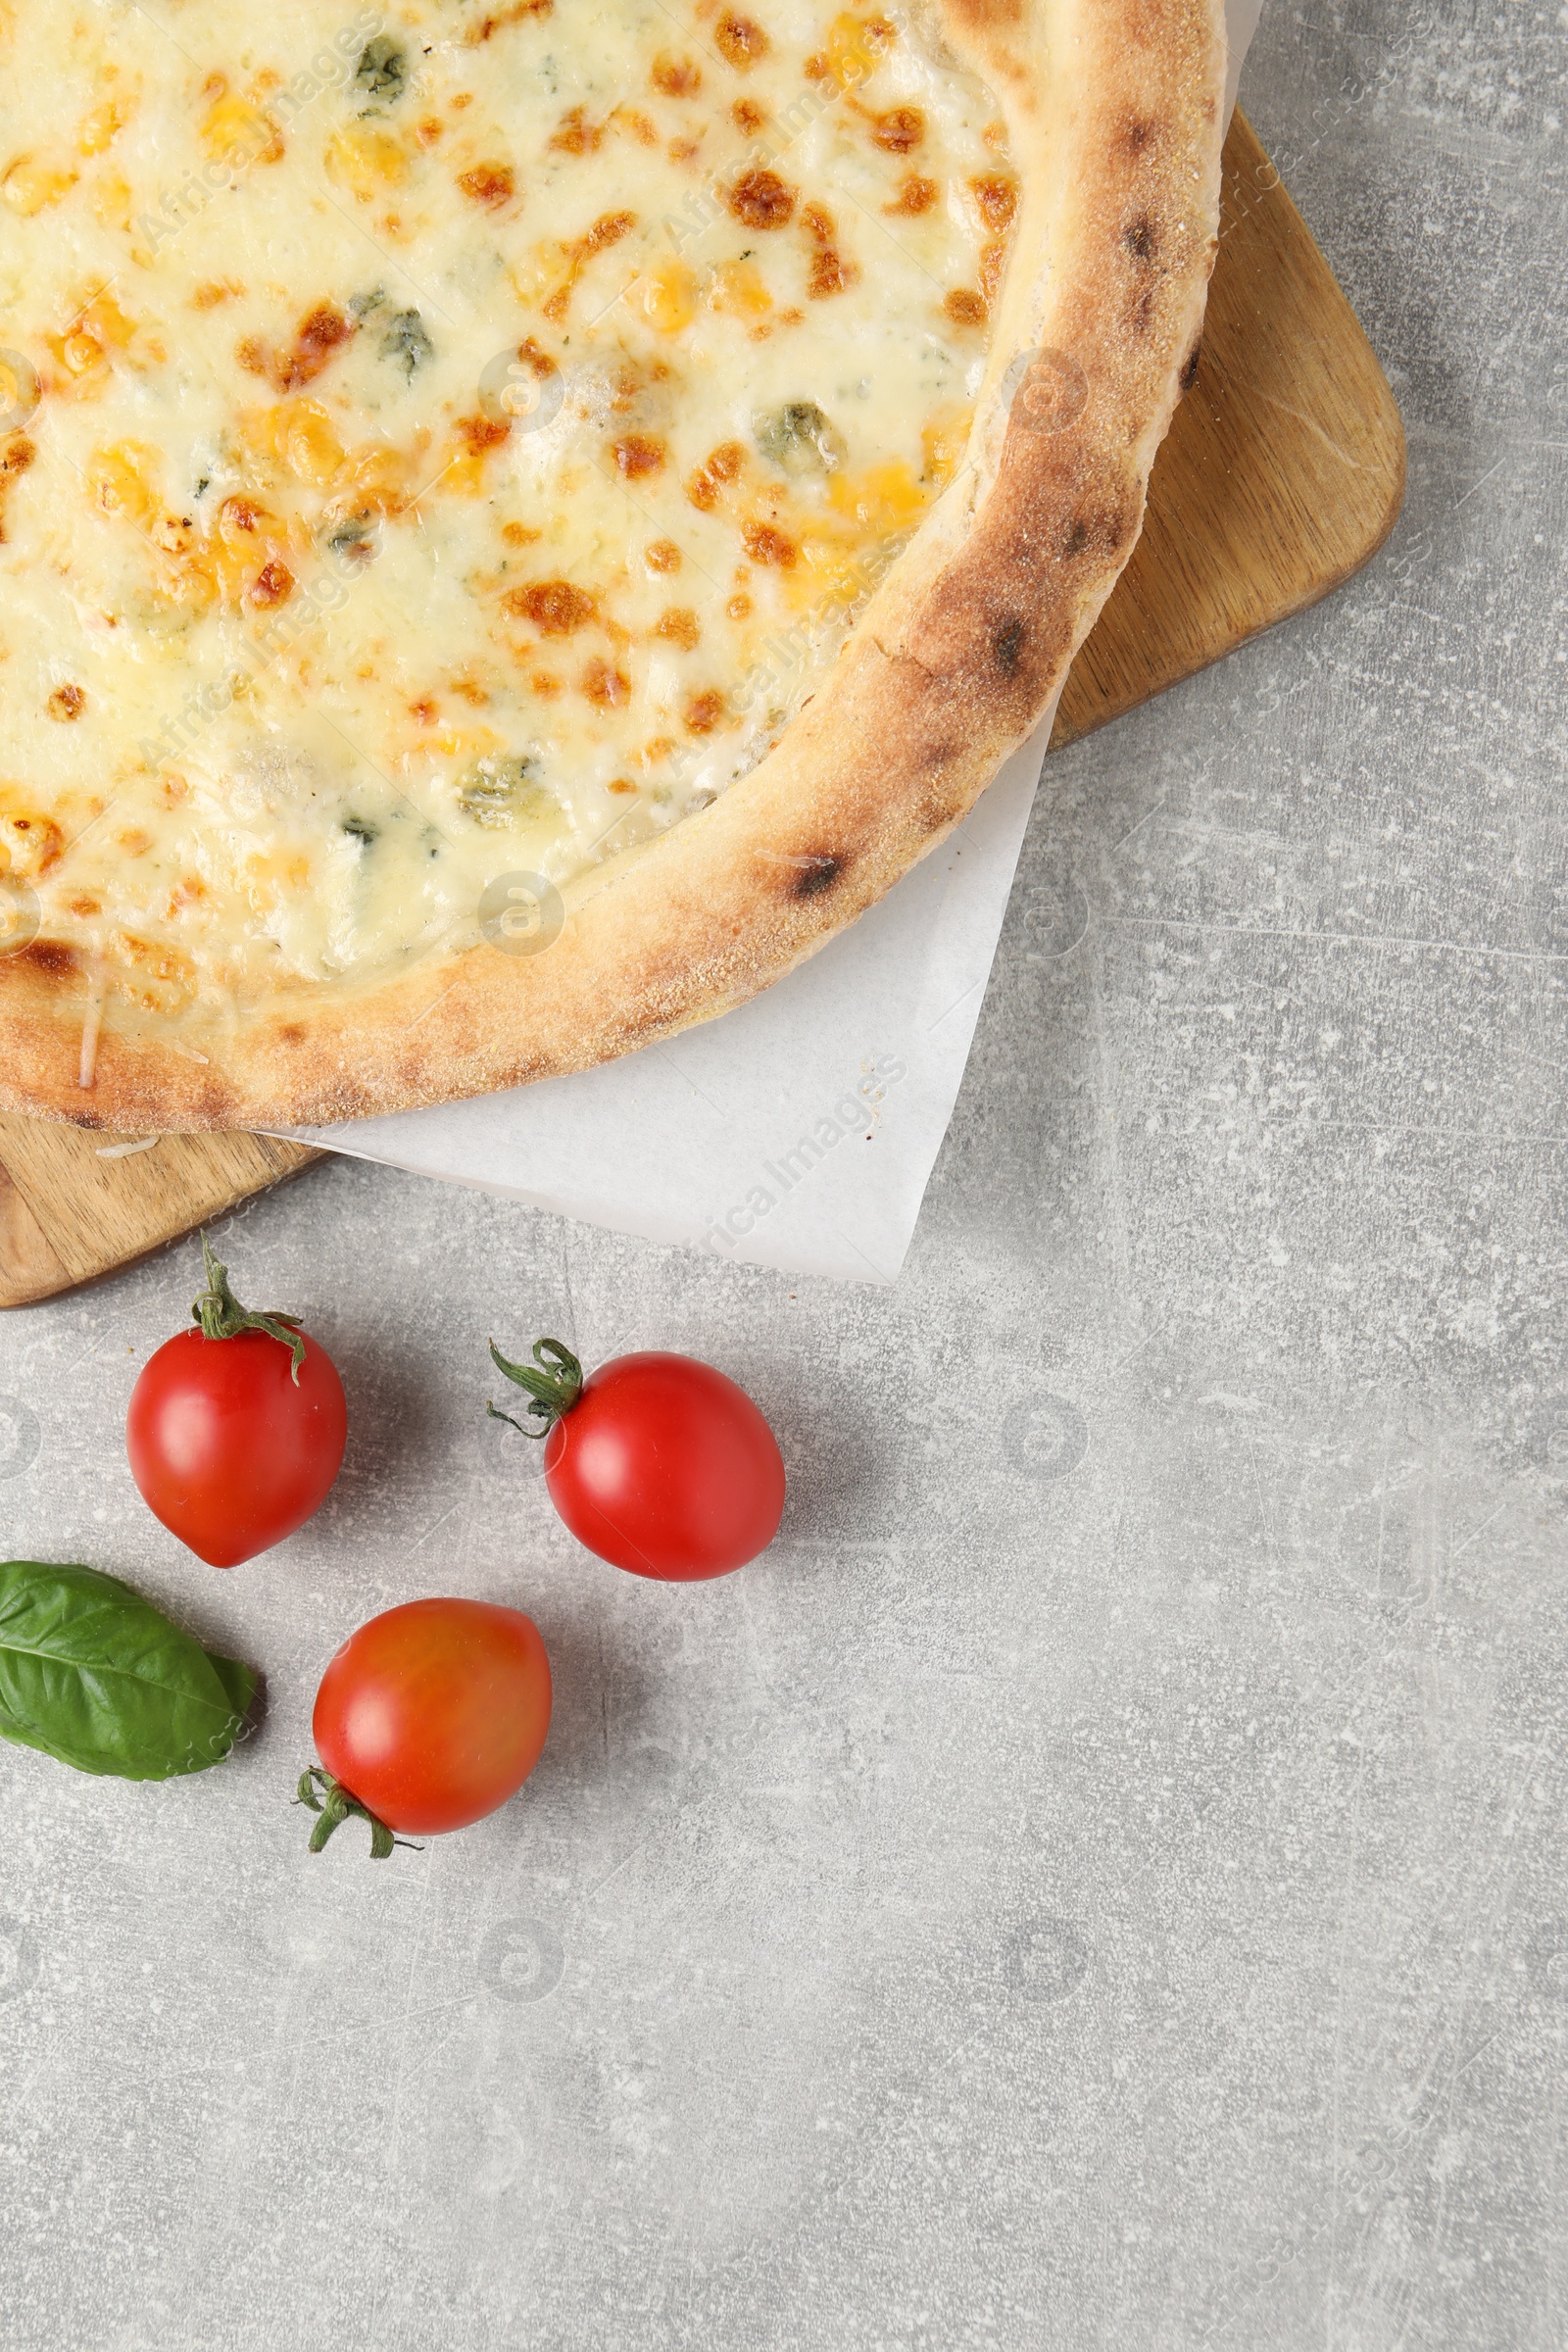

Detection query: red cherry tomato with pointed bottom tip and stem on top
(124, 1253), (348, 1569)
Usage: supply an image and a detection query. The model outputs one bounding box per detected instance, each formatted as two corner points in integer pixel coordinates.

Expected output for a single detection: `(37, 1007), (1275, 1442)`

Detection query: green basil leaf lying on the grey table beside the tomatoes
(0, 1559), (256, 1781)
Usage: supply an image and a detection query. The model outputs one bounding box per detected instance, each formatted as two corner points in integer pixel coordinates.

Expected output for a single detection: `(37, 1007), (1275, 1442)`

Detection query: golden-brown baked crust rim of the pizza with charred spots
(0, 0), (1225, 1129)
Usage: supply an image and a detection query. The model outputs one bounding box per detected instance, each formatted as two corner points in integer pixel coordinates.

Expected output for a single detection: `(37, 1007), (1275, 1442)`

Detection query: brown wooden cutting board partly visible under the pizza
(0, 116), (1405, 1307)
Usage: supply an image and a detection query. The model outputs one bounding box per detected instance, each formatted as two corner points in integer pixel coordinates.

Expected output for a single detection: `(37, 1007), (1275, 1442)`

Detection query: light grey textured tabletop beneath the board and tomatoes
(0, 0), (1568, 2352)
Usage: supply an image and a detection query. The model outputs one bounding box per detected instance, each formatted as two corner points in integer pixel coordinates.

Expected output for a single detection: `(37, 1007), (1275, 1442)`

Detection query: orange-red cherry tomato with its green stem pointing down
(301, 1601), (550, 1851)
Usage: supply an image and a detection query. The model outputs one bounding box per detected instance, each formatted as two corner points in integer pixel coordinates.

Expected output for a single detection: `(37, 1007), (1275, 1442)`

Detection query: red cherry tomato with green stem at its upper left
(491, 1341), (785, 1583)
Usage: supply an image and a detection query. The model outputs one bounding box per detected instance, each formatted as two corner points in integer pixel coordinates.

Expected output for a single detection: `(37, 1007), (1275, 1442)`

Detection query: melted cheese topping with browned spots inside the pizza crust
(0, 0), (1013, 1013)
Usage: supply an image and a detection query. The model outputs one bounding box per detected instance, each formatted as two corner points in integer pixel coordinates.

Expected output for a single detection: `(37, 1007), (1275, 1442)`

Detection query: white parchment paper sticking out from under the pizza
(285, 0), (1262, 1282)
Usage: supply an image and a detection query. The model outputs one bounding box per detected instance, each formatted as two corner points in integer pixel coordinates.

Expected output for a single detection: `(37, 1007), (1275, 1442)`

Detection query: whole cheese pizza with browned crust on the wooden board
(0, 0), (1225, 1129)
